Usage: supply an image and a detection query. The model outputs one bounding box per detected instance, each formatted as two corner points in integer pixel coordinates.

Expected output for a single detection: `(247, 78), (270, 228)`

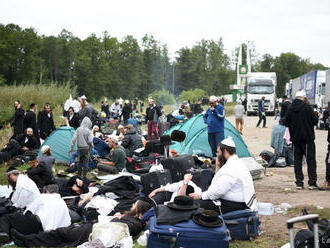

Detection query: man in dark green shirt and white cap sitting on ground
(97, 136), (126, 174)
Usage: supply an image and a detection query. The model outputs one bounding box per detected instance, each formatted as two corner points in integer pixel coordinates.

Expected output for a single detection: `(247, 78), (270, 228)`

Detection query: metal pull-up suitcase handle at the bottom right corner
(286, 214), (319, 248)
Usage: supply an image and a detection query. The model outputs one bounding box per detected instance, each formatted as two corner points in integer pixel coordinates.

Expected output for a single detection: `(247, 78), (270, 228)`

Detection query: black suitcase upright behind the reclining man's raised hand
(160, 154), (197, 183)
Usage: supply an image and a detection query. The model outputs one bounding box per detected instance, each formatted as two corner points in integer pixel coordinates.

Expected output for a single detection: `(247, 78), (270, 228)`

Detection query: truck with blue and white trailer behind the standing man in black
(288, 70), (324, 109)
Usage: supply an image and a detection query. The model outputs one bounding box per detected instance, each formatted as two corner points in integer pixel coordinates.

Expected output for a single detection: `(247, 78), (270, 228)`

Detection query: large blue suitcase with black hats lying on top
(147, 216), (229, 248)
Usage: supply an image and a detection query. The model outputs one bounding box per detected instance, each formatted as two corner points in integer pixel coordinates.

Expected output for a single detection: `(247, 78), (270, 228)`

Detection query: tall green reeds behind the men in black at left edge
(0, 84), (76, 124)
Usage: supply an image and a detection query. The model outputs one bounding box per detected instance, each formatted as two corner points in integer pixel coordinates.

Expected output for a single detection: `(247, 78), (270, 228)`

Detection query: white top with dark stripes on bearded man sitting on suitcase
(202, 155), (257, 210)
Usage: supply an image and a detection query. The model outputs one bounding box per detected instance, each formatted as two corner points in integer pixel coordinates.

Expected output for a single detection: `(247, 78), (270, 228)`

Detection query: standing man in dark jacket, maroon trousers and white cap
(146, 98), (164, 140)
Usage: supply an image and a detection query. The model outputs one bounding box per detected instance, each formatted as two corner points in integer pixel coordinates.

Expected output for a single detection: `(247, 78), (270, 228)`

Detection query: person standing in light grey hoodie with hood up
(71, 116), (94, 177)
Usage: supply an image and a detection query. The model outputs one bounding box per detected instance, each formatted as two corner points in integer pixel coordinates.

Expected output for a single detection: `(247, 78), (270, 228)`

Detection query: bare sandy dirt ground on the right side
(228, 116), (330, 247)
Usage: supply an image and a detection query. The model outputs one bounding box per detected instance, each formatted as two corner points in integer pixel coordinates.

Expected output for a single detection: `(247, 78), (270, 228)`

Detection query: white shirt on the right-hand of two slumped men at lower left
(34, 193), (71, 231)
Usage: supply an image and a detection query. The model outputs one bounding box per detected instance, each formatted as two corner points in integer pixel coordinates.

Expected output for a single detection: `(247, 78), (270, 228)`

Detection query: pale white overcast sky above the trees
(0, 0), (330, 67)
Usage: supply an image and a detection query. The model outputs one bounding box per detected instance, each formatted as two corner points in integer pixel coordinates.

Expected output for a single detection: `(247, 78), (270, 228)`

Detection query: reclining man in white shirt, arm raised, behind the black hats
(149, 174), (202, 204)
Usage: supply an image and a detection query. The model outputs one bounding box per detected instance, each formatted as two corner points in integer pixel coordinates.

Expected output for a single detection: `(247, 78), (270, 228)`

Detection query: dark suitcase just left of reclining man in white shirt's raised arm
(141, 170), (172, 195)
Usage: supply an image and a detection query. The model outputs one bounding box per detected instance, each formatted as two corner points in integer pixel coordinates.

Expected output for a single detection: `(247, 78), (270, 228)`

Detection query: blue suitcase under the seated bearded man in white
(222, 209), (260, 240)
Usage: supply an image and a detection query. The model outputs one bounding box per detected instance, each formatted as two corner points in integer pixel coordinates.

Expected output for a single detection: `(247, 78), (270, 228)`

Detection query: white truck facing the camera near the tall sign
(246, 72), (277, 115)
